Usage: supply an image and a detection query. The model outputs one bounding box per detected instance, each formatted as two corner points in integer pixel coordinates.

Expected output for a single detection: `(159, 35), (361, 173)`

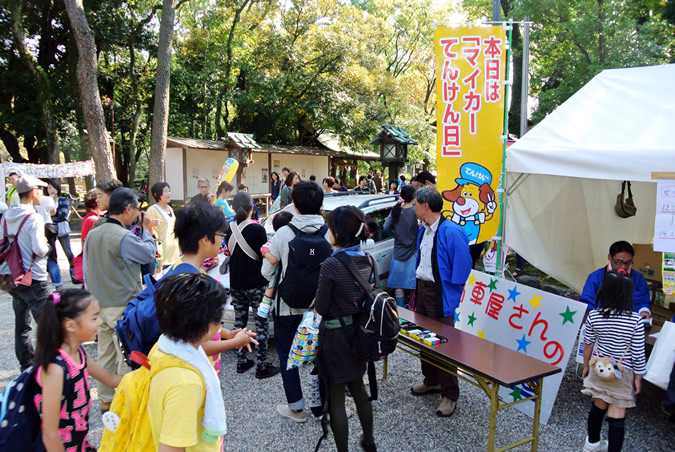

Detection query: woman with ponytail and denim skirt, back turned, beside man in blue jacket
(384, 184), (417, 306)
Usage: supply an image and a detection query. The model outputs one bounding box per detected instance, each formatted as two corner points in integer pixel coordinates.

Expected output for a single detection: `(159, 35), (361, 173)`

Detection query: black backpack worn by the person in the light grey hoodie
(279, 224), (333, 309)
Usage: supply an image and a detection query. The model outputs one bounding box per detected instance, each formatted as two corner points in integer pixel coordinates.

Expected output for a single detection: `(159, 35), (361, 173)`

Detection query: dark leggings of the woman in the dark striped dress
(328, 378), (375, 452)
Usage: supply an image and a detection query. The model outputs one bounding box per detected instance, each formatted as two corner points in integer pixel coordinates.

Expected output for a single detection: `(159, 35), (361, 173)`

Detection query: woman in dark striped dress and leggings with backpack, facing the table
(314, 206), (377, 452)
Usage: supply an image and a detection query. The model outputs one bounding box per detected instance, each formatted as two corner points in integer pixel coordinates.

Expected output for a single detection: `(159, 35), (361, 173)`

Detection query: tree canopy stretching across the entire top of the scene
(0, 0), (675, 187)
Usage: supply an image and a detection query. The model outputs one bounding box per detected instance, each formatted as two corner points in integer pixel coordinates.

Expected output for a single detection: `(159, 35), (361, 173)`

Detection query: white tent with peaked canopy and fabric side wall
(505, 64), (675, 291)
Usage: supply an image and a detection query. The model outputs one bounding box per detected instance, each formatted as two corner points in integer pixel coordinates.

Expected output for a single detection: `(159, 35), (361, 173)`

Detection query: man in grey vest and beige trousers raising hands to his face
(82, 187), (155, 411)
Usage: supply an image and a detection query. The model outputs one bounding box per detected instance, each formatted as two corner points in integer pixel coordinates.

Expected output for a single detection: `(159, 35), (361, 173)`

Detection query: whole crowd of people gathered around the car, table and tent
(0, 168), (672, 451)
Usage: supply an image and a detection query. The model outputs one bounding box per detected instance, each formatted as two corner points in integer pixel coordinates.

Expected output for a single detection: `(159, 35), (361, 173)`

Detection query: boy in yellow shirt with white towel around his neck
(147, 273), (235, 452)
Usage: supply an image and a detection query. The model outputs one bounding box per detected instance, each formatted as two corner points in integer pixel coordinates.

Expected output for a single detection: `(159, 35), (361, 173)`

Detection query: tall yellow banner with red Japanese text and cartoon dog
(434, 26), (507, 244)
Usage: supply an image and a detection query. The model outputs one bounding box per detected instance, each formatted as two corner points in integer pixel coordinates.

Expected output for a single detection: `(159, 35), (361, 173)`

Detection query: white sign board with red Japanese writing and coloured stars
(455, 270), (586, 424)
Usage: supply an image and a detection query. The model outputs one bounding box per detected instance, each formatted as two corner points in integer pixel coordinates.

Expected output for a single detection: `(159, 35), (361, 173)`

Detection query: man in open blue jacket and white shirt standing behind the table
(411, 186), (472, 417)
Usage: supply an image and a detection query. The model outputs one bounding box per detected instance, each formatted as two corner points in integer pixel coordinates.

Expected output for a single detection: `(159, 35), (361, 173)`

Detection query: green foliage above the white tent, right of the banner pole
(515, 0), (675, 123)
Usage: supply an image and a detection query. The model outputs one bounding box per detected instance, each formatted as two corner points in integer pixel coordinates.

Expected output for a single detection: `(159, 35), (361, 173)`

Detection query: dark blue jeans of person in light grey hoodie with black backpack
(274, 315), (305, 410)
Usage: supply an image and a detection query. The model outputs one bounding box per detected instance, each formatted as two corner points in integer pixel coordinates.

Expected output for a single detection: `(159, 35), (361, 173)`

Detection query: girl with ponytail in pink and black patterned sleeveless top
(35, 289), (122, 451)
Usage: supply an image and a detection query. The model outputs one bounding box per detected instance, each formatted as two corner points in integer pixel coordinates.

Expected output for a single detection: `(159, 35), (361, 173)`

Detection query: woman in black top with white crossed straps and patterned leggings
(225, 191), (279, 378)
